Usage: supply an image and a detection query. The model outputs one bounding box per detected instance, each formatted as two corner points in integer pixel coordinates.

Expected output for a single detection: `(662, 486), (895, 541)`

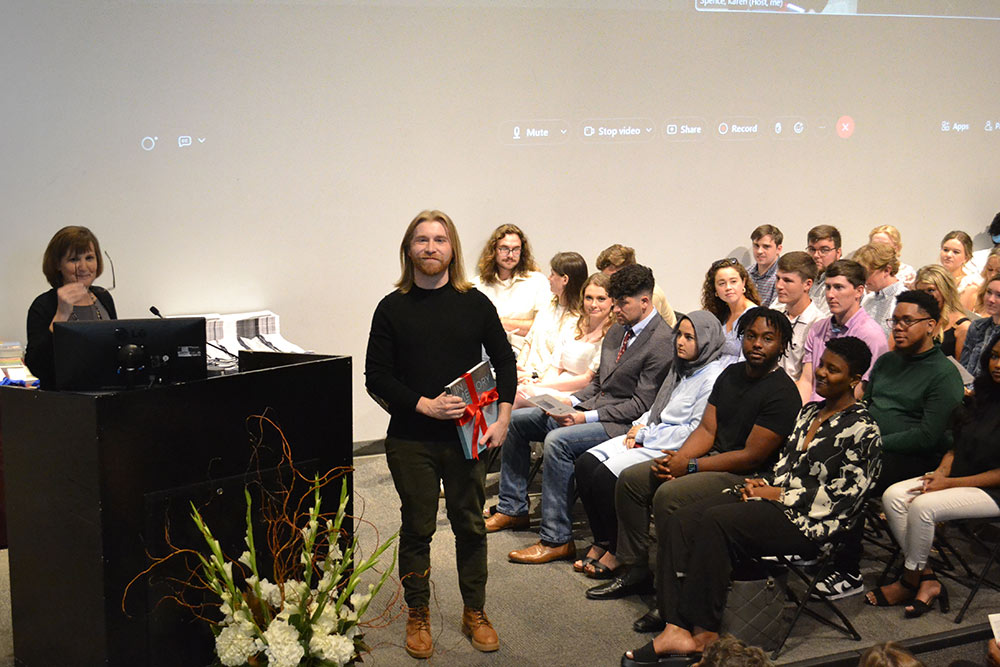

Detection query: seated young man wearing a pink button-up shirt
(796, 259), (889, 402)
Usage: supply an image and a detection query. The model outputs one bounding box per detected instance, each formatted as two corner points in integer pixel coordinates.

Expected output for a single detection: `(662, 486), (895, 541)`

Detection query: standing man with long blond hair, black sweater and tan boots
(365, 211), (517, 658)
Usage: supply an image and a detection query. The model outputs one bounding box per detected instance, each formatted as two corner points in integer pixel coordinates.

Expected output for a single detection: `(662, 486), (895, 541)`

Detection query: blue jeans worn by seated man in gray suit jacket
(497, 408), (608, 544)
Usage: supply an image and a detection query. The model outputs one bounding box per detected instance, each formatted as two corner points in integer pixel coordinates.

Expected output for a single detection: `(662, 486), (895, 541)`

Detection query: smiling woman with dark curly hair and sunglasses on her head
(701, 257), (760, 365)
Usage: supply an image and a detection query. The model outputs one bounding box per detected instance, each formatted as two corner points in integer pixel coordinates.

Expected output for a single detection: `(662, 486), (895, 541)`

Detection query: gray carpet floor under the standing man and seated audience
(0, 455), (1000, 667)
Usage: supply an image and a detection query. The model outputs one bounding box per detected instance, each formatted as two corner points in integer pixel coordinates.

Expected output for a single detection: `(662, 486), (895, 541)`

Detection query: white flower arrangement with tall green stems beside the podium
(191, 478), (398, 667)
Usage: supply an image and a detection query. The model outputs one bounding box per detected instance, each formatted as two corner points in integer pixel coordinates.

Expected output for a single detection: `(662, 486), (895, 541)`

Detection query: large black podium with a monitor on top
(0, 353), (353, 667)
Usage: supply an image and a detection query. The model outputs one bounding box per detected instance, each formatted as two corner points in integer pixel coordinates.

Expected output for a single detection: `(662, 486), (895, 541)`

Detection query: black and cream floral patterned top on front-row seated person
(767, 402), (882, 541)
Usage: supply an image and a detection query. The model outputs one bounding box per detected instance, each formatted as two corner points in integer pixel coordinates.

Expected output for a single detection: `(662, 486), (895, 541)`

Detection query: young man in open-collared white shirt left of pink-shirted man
(774, 250), (823, 380)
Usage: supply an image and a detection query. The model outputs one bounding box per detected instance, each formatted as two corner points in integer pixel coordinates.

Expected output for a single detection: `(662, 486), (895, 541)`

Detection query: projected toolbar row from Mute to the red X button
(500, 115), (854, 146)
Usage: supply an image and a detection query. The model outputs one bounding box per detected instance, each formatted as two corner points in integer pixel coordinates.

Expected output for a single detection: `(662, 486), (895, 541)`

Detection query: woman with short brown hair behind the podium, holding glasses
(24, 226), (118, 389)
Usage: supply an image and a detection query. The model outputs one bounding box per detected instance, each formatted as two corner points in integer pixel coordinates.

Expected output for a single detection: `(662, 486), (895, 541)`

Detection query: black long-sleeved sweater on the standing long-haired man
(365, 284), (517, 442)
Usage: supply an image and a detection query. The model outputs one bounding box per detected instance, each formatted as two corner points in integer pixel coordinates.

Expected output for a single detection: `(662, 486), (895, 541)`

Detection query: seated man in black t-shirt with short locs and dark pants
(587, 308), (802, 616)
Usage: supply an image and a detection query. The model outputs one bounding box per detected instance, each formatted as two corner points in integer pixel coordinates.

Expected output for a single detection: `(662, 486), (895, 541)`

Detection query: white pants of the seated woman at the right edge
(882, 477), (1000, 570)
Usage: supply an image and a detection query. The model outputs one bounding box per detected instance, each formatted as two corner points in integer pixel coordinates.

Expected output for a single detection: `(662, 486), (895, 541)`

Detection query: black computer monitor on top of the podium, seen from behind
(52, 317), (207, 391)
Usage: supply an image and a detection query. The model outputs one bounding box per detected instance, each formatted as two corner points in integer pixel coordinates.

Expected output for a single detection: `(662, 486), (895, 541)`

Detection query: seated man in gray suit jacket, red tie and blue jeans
(486, 264), (674, 563)
